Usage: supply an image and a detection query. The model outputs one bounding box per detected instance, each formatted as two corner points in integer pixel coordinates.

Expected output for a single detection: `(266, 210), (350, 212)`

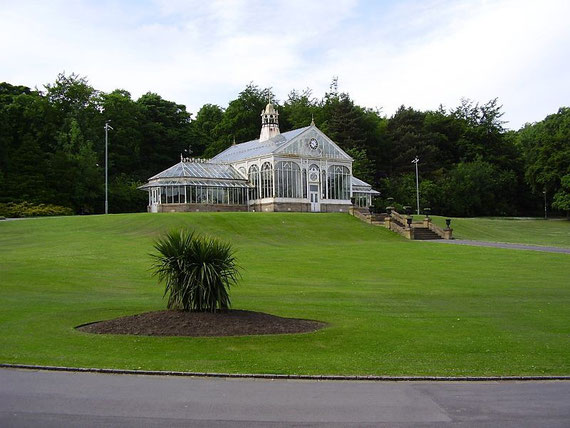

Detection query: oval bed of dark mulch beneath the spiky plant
(77, 310), (326, 337)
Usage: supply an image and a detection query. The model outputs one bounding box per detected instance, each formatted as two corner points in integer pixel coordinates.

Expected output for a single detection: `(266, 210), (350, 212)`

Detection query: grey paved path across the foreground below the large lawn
(0, 369), (570, 427)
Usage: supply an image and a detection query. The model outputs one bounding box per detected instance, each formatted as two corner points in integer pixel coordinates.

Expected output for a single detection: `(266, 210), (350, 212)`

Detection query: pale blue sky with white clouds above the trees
(0, 0), (570, 129)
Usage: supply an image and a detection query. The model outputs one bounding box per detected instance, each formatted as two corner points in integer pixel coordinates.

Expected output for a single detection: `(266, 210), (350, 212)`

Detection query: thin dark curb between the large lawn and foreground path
(0, 364), (570, 382)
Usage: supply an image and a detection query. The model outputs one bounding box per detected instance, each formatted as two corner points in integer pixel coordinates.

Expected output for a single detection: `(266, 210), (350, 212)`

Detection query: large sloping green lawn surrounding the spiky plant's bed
(0, 213), (570, 376)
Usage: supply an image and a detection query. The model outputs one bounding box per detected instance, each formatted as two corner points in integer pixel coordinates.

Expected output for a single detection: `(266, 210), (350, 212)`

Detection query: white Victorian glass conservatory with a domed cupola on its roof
(141, 103), (378, 212)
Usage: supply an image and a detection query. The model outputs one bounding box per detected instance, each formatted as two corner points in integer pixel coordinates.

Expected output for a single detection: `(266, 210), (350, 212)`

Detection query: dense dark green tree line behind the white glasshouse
(0, 73), (570, 216)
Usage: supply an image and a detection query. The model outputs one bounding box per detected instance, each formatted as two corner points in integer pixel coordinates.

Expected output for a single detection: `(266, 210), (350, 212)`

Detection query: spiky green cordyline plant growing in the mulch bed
(152, 229), (239, 312)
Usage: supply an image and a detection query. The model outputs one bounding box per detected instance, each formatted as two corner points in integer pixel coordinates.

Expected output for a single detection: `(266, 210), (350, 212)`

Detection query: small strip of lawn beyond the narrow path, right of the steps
(414, 216), (570, 248)
